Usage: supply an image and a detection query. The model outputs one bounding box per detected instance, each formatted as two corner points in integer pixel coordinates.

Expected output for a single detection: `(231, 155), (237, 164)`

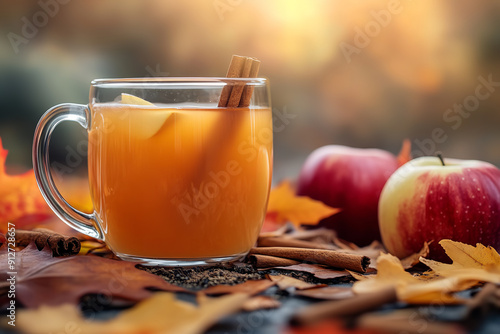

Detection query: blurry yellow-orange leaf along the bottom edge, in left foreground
(18, 292), (248, 334)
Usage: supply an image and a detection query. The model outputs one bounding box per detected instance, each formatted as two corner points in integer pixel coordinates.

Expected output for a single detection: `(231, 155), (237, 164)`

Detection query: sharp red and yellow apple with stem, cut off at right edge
(379, 157), (500, 261)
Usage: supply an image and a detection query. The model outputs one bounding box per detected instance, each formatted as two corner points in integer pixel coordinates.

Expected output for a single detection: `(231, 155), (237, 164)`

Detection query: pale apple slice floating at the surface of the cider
(121, 93), (173, 139)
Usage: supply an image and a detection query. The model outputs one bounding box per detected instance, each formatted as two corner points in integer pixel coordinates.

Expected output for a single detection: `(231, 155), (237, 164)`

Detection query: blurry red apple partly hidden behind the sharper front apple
(297, 141), (410, 246)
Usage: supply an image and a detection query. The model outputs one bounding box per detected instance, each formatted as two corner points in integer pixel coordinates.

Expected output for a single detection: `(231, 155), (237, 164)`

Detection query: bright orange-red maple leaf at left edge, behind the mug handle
(0, 138), (52, 231)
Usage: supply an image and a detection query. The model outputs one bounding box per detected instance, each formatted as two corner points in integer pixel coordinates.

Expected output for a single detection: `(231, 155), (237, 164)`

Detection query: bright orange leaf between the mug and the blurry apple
(267, 181), (340, 230)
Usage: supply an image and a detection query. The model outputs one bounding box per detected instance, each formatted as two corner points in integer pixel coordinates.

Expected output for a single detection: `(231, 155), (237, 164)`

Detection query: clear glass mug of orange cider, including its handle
(33, 78), (273, 265)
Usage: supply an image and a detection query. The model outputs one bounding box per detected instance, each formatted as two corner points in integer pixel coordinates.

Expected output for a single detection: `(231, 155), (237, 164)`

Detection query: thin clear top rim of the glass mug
(90, 77), (268, 87)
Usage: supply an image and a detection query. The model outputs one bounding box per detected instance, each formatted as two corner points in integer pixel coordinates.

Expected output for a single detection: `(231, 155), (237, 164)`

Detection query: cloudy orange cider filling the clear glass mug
(89, 104), (272, 259)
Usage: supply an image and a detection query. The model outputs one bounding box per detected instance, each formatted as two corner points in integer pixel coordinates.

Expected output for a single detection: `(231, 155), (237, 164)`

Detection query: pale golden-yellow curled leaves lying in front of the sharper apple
(351, 240), (500, 304)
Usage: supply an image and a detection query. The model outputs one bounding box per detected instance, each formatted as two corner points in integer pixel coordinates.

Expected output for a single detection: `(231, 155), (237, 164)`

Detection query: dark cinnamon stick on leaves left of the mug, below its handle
(16, 228), (81, 256)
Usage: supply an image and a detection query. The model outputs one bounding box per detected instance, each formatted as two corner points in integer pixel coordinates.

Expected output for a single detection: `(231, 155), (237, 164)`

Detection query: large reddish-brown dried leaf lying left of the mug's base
(0, 244), (186, 308)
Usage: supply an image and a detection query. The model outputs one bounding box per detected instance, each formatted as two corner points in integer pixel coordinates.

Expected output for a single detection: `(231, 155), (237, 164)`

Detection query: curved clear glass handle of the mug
(33, 103), (103, 240)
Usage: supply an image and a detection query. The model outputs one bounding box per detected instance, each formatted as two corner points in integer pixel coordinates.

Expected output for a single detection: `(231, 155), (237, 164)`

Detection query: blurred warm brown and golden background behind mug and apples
(0, 0), (500, 182)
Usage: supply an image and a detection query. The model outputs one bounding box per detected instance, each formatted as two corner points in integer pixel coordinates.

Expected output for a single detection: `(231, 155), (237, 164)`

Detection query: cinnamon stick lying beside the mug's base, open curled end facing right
(250, 247), (370, 272)
